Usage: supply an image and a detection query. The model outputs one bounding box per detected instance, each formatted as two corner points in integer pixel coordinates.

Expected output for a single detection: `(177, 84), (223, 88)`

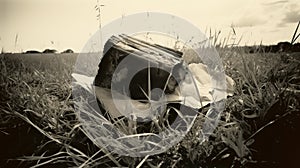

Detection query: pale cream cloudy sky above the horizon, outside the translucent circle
(0, 0), (300, 52)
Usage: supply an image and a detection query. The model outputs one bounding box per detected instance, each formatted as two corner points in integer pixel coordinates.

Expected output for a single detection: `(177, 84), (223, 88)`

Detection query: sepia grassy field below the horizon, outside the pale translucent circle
(0, 49), (300, 167)
